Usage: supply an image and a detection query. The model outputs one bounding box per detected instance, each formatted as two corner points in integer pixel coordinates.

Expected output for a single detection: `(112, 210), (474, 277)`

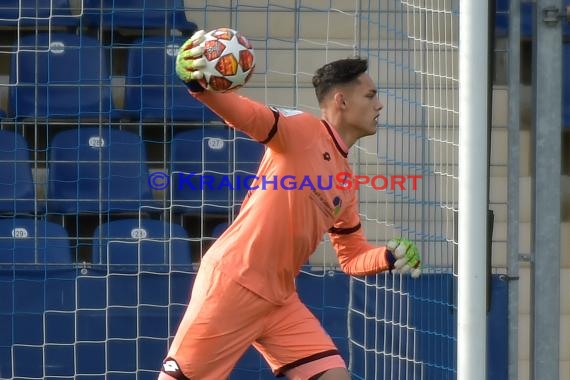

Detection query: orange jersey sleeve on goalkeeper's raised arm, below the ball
(190, 91), (285, 151)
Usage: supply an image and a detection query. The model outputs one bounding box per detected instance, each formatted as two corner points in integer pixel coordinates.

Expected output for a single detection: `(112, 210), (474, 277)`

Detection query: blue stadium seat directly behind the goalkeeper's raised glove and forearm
(124, 37), (220, 122)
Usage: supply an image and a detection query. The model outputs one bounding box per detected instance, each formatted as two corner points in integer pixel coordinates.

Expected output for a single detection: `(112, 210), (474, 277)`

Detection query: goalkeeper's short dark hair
(313, 57), (368, 104)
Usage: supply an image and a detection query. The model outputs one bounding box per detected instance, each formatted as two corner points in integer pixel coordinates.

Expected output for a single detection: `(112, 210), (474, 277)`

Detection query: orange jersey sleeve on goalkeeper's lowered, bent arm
(329, 191), (390, 276)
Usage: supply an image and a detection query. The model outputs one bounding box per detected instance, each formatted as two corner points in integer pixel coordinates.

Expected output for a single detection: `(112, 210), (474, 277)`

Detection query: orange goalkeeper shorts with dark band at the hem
(162, 263), (346, 380)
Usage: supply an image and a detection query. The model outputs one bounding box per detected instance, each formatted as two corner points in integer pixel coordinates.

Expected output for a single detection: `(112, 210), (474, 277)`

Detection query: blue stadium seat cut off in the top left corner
(0, 0), (79, 27)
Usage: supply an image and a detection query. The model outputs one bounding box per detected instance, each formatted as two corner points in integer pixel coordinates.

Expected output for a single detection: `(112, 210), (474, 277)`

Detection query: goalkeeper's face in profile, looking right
(344, 73), (384, 138)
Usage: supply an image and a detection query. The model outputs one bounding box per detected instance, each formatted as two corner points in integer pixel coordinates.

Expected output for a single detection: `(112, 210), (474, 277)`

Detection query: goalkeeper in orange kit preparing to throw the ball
(159, 31), (421, 380)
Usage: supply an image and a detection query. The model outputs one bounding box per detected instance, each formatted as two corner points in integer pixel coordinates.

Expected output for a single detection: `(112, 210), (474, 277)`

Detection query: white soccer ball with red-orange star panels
(200, 28), (255, 92)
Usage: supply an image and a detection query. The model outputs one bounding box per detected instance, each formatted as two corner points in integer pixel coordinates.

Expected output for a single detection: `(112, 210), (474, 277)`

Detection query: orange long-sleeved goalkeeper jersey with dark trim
(192, 91), (389, 304)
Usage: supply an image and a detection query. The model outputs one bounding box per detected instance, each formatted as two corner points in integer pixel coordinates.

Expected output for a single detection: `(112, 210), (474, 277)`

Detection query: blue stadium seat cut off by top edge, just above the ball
(83, 0), (197, 35)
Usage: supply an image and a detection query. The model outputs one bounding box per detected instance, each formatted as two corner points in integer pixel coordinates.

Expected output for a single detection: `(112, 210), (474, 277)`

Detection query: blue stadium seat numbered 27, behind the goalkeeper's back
(171, 127), (264, 214)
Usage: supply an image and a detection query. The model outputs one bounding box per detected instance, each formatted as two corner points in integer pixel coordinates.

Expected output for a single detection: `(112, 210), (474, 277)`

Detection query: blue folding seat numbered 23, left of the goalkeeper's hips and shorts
(93, 218), (193, 371)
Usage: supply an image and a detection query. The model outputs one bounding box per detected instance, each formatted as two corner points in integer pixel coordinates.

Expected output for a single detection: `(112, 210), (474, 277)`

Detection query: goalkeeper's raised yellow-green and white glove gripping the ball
(176, 30), (206, 92)
